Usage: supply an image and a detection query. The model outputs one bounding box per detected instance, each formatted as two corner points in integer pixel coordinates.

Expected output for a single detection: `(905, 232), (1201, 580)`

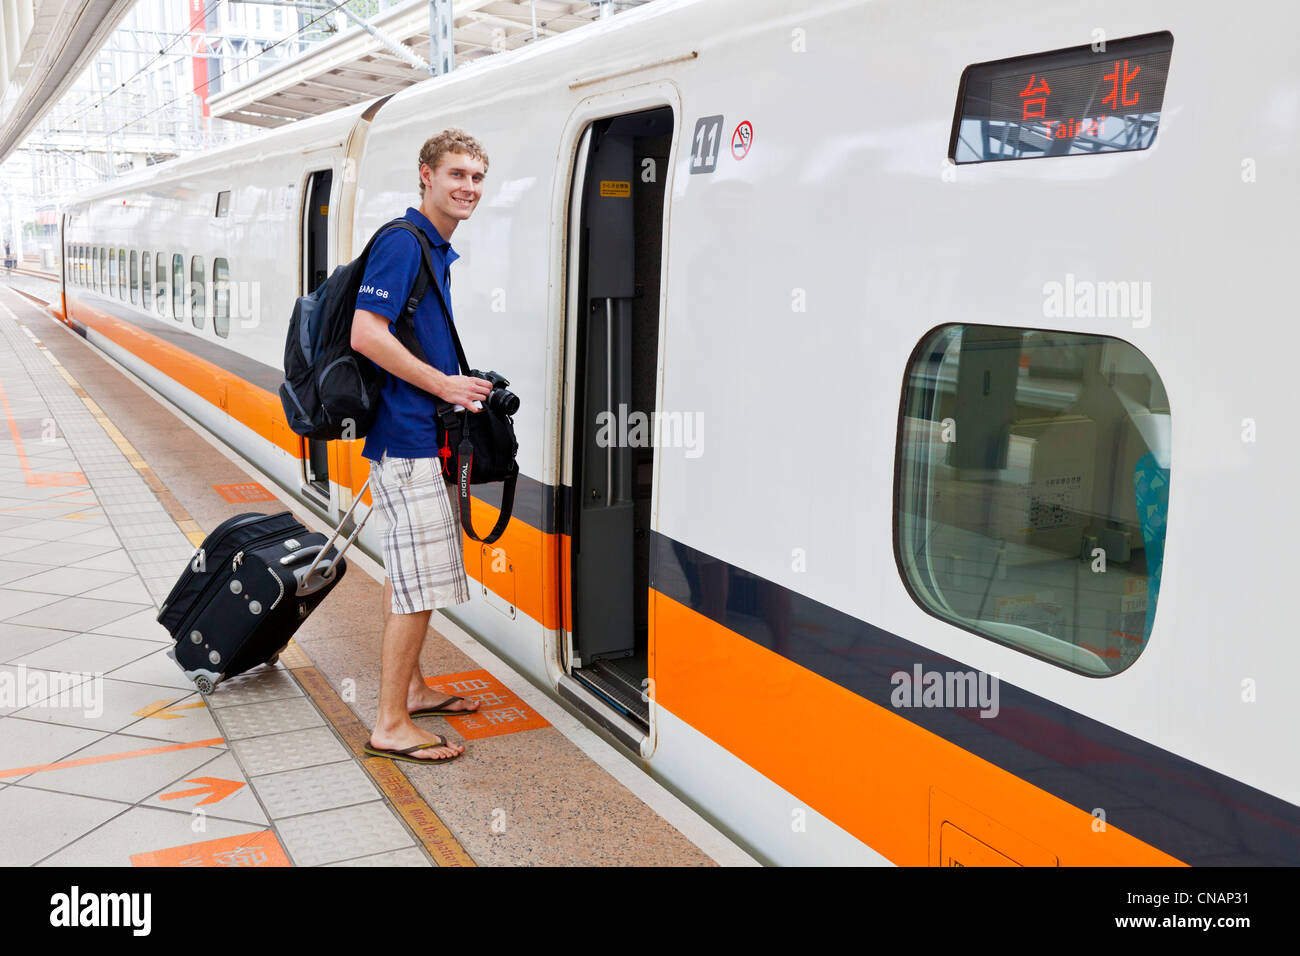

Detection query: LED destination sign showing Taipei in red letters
(948, 33), (1174, 163)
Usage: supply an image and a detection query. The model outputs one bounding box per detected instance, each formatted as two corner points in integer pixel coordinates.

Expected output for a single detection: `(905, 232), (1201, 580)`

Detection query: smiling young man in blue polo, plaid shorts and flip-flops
(352, 129), (491, 763)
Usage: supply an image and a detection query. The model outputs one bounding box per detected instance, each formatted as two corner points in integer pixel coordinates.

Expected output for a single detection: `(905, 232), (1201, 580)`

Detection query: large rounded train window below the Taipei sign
(894, 325), (1170, 676)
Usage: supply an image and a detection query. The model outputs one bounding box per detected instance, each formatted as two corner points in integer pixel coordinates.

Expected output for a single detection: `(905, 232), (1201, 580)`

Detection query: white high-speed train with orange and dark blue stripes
(53, 0), (1300, 865)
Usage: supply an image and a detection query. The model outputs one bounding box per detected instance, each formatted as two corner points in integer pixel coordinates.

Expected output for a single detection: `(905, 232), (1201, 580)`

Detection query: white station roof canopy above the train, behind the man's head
(210, 0), (637, 126)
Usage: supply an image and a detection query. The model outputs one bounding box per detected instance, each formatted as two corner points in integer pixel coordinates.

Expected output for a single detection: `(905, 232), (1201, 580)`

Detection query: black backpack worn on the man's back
(280, 219), (432, 441)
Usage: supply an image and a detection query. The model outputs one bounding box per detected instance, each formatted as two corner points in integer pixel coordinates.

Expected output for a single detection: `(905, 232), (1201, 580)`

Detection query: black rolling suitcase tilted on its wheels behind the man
(157, 481), (371, 693)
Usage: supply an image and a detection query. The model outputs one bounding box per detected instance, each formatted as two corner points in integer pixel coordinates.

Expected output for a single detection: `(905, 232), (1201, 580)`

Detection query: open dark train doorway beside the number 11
(562, 107), (673, 727)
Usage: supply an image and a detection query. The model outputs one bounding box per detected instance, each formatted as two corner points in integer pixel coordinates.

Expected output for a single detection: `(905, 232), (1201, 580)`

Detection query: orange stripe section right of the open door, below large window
(650, 591), (1182, 866)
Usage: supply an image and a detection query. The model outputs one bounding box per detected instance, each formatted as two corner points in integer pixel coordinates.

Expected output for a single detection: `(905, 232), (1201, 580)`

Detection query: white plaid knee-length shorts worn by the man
(371, 454), (469, 614)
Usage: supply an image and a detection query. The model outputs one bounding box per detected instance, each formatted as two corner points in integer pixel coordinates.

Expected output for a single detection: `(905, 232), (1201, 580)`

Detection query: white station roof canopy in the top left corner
(0, 0), (134, 163)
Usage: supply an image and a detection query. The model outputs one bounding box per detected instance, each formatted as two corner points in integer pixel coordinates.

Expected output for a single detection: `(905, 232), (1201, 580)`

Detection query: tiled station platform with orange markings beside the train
(0, 280), (754, 866)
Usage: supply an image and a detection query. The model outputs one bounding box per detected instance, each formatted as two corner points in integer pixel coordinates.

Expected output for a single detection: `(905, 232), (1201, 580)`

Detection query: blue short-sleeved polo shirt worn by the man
(356, 207), (460, 462)
